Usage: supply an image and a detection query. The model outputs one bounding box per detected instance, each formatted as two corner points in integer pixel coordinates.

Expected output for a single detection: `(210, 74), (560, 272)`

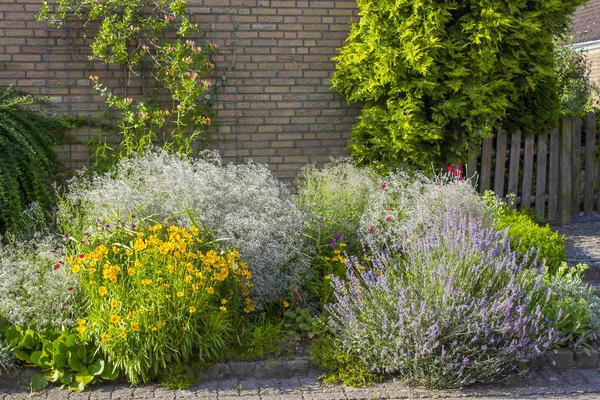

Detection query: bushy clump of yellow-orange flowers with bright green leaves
(68, 224), (254, 383)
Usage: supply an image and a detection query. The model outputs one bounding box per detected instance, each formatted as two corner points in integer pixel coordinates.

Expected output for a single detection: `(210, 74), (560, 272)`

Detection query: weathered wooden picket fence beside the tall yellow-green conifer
(467, 112), (600, 225)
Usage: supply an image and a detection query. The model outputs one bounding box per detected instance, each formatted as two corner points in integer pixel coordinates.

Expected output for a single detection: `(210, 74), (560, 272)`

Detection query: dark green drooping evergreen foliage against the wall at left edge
(0, 88), (73, 232)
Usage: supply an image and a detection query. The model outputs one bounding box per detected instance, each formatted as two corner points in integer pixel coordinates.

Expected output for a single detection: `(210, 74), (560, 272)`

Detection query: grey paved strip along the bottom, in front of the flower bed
(0, 368), (600, 400)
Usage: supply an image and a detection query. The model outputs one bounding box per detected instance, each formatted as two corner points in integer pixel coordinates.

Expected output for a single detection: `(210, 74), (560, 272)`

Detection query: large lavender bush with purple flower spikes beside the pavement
(327, 212), (557, 388)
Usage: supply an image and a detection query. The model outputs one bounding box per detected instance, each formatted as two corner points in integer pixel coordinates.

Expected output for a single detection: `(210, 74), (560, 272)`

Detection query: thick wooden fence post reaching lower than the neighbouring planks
(558, 118), (573, 226)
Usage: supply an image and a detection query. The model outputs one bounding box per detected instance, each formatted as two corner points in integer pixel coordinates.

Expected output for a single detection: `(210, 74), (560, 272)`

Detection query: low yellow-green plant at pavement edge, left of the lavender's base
(309, 335), (381, 387)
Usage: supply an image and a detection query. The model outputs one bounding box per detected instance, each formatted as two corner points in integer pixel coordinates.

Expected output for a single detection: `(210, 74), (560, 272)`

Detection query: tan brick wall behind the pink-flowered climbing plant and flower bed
(0, 0), (360, 180)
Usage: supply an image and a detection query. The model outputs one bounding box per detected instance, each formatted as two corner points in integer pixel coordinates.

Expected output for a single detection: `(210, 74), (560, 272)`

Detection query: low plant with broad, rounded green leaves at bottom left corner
(5, 320), (119, 392)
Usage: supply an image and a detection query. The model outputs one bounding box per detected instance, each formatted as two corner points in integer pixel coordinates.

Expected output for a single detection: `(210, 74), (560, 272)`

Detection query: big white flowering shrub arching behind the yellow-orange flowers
(58, 150), (310, 307)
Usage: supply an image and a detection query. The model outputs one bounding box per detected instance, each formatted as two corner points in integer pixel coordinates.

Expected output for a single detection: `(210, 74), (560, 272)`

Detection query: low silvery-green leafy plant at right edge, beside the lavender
(544, 262), (600, 350)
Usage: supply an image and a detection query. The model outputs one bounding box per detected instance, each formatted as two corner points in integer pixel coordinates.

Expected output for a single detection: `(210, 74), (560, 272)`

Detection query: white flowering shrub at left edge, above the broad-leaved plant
(0, 235), (80, 330)
